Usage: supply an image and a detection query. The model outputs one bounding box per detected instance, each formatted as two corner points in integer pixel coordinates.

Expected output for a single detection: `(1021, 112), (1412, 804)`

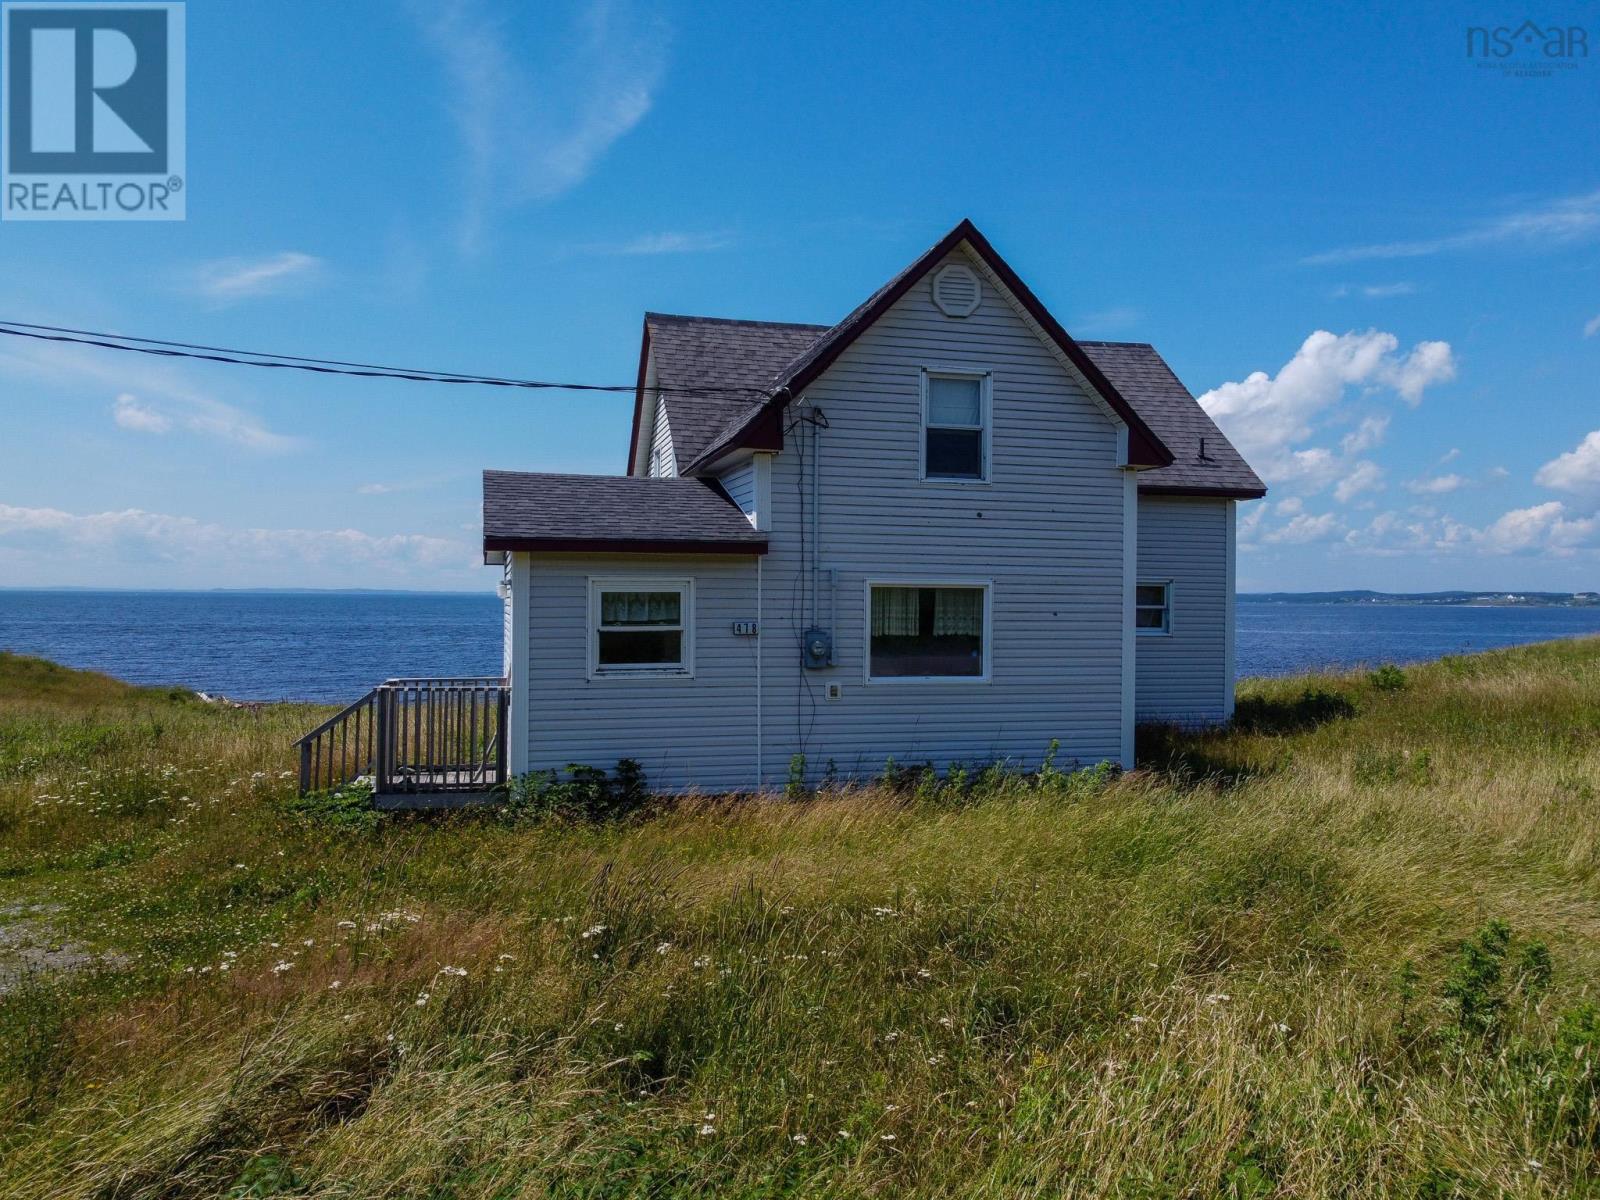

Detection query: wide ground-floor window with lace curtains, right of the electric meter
(869, 584), (987, 678)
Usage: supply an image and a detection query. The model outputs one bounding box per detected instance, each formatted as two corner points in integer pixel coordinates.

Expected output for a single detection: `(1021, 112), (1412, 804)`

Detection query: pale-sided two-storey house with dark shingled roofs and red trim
(291, 221), (1266, 803)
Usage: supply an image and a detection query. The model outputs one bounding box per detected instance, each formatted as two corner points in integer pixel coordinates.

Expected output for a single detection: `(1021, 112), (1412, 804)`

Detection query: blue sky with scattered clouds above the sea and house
(0, 0), (1600, 590)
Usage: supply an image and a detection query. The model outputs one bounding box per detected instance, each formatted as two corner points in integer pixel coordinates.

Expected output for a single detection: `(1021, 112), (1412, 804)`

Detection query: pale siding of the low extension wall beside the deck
(528, 555), (757, 790)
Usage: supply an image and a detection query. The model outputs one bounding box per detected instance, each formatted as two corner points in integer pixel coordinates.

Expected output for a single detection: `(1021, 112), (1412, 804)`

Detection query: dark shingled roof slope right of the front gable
(1078, 341), (1267, 499)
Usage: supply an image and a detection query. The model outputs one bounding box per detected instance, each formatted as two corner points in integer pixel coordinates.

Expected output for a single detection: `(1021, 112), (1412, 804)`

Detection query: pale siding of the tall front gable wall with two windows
(748, 251), (1125, 784)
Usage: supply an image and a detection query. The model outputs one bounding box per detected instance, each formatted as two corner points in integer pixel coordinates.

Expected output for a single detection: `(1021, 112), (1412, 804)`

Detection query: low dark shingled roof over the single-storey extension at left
(483, 470), (766, 554)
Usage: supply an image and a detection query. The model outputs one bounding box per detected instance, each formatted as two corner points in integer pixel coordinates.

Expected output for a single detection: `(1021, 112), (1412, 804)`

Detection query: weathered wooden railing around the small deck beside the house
(296, 677), (510, 795)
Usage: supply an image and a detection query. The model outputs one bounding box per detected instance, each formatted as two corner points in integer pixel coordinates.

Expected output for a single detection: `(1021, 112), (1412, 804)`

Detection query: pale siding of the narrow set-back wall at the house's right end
(1136, 496), (1232, 725)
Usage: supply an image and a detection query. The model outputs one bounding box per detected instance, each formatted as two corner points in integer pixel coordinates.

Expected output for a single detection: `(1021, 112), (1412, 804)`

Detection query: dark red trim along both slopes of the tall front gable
(685, 219), (1173, 474)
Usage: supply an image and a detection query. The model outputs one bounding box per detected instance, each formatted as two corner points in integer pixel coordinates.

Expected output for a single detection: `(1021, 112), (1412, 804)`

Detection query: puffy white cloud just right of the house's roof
(1200, 330), (1456, 490)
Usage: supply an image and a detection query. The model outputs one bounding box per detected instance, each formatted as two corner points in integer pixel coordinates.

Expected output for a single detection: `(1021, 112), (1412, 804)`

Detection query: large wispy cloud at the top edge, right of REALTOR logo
(411, 0), (669, 253)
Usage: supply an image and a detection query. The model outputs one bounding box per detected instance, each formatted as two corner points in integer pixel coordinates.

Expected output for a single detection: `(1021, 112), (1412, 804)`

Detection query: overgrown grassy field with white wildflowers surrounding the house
(0, 640), (1600, 1198)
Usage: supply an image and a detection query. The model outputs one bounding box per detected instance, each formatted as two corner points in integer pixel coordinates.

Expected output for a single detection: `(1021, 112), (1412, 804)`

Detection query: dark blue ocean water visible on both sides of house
(0, 590), (1600, 702)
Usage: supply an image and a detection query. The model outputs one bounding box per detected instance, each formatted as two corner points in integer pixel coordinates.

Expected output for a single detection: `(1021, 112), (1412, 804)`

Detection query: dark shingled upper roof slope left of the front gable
(645, 312), (829, 467)
